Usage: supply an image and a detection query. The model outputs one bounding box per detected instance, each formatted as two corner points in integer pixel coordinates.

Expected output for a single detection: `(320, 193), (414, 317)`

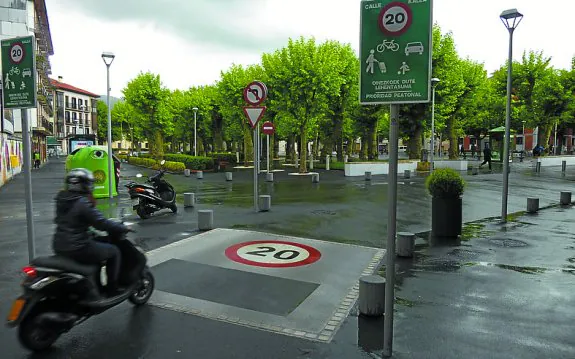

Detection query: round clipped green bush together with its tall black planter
(425, 168), (465, 237)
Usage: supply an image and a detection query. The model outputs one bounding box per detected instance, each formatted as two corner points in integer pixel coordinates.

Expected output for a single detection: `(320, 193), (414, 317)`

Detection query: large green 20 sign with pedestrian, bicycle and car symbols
(359, 0), (433, 105)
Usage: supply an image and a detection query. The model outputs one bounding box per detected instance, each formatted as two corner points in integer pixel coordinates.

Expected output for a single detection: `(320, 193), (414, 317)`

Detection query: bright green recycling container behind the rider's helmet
(66, 146), (119, 198)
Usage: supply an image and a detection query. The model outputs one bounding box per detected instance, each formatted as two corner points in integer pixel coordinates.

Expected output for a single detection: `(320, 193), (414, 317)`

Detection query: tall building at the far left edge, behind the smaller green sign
(0, 0), (54, 185)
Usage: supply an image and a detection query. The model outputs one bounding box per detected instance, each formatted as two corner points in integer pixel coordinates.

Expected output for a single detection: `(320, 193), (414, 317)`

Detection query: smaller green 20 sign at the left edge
(1, 36), (36, 109)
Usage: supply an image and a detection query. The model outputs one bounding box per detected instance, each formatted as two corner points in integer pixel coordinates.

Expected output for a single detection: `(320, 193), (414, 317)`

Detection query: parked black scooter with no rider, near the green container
(125, 160), (178, 219)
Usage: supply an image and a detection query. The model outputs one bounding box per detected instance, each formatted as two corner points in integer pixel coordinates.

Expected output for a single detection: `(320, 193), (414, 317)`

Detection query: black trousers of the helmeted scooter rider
(66, 237), (122, 289)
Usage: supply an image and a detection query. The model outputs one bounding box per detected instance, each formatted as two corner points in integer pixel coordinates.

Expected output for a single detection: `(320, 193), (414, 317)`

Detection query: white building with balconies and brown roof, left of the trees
(51, 77), (100, 154)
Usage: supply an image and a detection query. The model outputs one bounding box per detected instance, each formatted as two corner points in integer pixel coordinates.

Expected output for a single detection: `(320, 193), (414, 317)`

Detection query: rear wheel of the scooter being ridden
(18, 312), (61, 352)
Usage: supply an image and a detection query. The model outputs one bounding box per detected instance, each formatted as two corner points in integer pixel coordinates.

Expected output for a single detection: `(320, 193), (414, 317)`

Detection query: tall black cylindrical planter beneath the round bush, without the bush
(431, 197), (463, 237)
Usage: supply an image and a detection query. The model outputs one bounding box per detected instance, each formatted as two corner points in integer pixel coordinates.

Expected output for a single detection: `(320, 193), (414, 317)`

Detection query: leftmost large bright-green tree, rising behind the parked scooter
(122, 72), (173, 158)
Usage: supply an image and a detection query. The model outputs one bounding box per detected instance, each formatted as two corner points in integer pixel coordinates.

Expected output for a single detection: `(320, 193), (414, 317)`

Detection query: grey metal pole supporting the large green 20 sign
(383, 104), (399, 357)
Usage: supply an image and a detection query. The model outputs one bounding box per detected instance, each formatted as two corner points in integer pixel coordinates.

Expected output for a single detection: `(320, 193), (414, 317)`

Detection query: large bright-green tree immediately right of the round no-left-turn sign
(262, 37), (345, 173)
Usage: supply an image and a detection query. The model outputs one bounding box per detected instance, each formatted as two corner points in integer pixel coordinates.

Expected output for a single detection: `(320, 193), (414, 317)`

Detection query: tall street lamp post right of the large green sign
(499, 9), (523, 222)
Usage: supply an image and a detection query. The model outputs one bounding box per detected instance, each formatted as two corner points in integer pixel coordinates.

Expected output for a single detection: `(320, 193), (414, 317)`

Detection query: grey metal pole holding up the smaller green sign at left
(20, 109), (36, 261)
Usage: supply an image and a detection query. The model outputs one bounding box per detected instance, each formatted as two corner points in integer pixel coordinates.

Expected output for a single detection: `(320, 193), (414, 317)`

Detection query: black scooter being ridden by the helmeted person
(6, 219), (154, 352)
